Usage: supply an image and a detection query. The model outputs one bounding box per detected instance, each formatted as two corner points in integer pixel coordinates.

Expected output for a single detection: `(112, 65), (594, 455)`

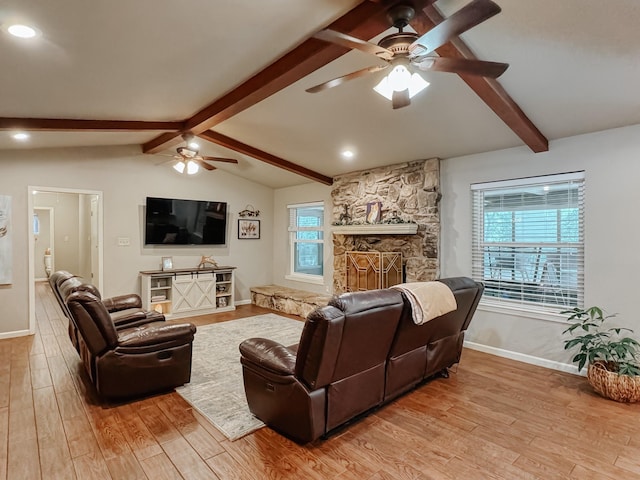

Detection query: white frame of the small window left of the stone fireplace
(285, 201), (325, 285)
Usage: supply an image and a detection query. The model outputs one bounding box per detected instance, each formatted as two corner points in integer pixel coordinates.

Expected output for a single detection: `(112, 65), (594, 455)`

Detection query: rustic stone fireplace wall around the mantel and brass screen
(331, 158), (440, 294)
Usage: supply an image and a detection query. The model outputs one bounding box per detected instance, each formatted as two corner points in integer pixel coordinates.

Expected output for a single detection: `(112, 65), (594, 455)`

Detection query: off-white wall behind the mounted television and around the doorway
(0, 146), (273, 336)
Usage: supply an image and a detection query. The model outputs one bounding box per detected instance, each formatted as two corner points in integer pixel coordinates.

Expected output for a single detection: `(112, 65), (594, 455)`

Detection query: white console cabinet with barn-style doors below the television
(140, 267), (236, 318)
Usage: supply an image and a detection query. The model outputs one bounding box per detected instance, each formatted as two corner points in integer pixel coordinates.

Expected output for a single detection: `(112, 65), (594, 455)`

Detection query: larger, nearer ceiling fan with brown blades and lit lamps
(306, 0), (509, 109)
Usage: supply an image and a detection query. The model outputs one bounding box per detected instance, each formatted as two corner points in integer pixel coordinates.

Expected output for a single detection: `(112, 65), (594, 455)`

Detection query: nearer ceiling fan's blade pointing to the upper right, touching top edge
(409, 0), (501, 57)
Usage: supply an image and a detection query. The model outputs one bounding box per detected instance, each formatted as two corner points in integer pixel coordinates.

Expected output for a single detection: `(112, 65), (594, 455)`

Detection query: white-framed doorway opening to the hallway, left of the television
(28, 186), (103, 332)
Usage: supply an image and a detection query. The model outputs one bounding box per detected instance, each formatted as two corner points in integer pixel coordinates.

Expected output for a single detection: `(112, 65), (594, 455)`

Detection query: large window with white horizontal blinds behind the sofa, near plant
(471, 172), (584, 312)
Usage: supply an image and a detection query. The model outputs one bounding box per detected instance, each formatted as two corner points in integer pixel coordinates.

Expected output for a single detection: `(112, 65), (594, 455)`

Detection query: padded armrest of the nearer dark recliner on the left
(118, 322), (196, 348)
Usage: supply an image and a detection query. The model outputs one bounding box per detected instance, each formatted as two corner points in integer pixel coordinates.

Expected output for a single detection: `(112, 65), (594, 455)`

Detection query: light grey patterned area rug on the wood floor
(176, 313), (304, 440)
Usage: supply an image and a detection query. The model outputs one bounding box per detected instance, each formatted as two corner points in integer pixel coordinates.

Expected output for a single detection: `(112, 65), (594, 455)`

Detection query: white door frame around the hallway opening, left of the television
(27, 185), (104, 334)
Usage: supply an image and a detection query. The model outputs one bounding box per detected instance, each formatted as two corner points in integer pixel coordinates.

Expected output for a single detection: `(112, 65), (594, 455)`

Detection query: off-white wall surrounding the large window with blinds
(441, 125), (640, 363)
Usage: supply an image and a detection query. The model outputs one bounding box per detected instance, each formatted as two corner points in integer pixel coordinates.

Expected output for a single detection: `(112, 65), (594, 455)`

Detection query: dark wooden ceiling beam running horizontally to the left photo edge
(0, 117), (183, 132)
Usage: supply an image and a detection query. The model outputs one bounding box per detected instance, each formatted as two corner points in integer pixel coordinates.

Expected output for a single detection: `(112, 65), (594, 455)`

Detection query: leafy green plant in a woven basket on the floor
(562, 307), (640, 402)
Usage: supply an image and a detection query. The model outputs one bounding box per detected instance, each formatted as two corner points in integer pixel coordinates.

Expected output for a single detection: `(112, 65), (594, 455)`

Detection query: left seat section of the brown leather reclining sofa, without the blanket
(240, 290), (404, 442)
